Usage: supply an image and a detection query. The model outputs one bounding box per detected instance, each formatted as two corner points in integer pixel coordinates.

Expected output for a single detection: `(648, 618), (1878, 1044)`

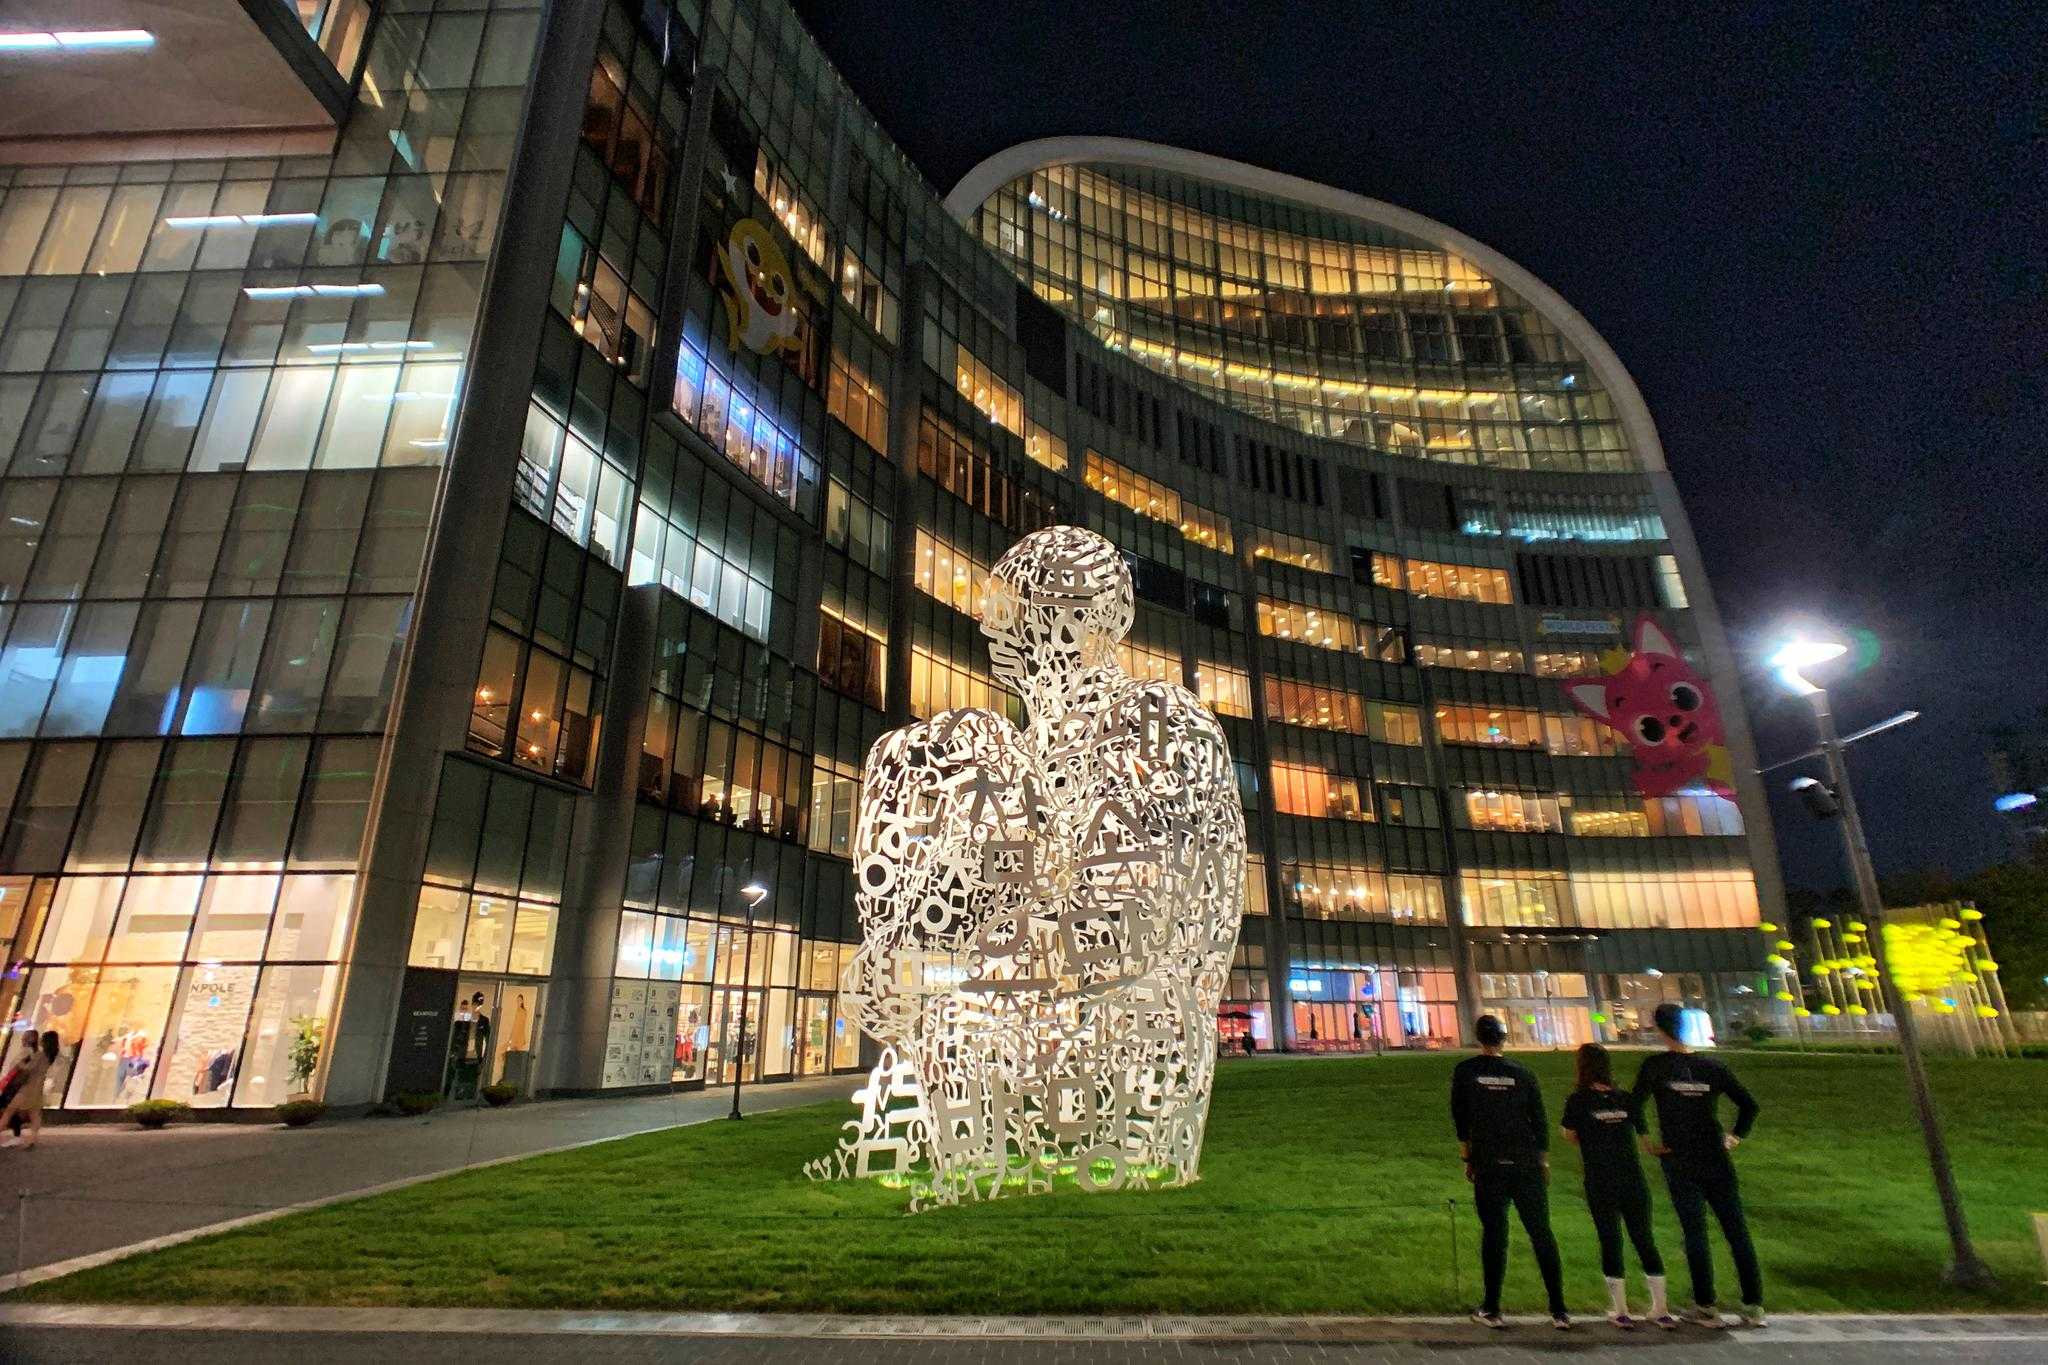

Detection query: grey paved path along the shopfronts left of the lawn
(0, 1076), (860, 1291)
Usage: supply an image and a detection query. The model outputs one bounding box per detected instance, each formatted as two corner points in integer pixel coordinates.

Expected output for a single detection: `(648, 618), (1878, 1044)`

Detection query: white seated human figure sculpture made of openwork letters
(805, 526), (1245, 1212)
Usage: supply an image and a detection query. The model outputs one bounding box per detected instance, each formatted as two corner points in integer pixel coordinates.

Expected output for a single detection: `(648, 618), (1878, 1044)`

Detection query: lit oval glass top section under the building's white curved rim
(975, 164), (1638, 473)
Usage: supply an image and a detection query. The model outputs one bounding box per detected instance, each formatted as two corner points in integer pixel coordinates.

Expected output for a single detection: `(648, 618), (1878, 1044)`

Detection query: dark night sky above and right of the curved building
(799, 0), (2048, 888)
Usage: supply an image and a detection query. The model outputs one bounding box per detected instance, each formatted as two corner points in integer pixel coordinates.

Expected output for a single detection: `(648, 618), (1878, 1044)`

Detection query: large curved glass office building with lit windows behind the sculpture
(0, 0), (1780, 1111)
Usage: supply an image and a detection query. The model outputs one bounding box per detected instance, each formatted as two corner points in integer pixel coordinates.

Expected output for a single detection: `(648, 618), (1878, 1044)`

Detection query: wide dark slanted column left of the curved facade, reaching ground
(322, 0), (604, 1105)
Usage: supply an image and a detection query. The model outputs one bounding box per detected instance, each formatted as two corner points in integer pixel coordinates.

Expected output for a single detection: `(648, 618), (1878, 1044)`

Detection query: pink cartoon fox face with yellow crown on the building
(1565, 616), (1735, 798)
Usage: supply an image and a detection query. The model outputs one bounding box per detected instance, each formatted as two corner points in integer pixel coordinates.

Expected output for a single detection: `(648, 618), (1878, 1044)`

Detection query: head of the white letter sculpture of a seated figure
(981, 526), (1137, 716)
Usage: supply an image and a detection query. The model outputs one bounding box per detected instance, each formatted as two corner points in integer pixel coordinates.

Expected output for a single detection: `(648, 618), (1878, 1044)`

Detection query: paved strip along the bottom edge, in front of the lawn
(0, 1306), (2048, 1365)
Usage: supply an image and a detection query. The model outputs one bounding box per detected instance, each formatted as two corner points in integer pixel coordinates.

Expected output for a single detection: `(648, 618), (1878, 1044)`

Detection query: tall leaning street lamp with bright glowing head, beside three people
(1772, 641), (1997, 1289)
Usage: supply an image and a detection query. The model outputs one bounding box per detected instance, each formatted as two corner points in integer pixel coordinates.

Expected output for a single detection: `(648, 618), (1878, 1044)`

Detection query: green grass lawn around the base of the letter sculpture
(14, 1054), (2048, 1314)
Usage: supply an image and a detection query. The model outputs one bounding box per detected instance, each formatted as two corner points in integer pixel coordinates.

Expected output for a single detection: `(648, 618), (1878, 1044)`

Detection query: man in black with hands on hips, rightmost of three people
(1634, 1001), (1763, 1326)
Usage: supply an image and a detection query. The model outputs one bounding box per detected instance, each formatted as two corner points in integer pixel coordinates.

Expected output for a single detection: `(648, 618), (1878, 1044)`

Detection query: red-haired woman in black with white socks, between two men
(1563, 1044), (1677, 1330)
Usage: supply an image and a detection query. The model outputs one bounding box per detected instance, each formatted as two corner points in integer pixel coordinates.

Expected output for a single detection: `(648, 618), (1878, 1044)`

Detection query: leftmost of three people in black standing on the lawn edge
(1450, 1015), (1571, 1332)
